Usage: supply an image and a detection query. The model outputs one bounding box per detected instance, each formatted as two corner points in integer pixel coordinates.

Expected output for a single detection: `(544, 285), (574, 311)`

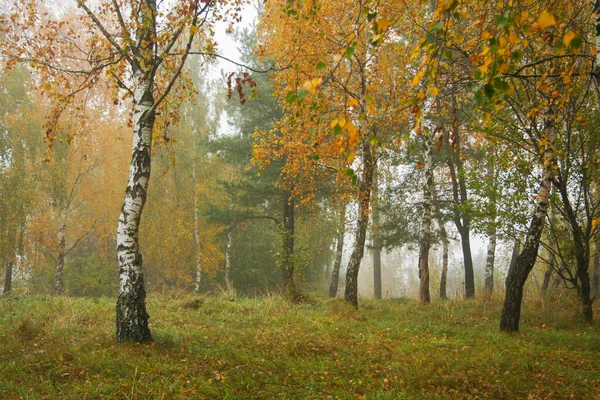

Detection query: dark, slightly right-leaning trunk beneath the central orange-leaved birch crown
(344, 139), (375, 308)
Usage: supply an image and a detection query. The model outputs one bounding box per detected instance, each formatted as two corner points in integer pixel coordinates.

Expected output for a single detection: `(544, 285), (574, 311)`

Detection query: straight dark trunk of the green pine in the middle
(281, 191), (298, 300)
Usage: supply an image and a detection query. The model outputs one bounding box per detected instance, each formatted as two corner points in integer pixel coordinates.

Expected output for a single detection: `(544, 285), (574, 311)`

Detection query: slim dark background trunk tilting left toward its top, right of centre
(448, 106), (475, 298)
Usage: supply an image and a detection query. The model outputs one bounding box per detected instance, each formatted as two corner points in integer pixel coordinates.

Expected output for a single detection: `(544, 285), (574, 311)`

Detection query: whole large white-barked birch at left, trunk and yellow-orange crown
(2, 0), (241, 342)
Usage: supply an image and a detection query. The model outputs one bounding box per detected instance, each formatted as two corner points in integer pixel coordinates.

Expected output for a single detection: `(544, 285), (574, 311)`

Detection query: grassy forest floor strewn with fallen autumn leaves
(0, 293), (600, 400)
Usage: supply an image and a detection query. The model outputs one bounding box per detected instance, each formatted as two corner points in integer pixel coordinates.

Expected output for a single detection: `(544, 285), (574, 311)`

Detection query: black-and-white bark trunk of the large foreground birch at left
(117, 71), (155, 342)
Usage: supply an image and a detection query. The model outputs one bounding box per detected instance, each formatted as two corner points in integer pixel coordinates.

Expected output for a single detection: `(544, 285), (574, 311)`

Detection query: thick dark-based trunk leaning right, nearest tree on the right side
(500, 110), (556, 332)
